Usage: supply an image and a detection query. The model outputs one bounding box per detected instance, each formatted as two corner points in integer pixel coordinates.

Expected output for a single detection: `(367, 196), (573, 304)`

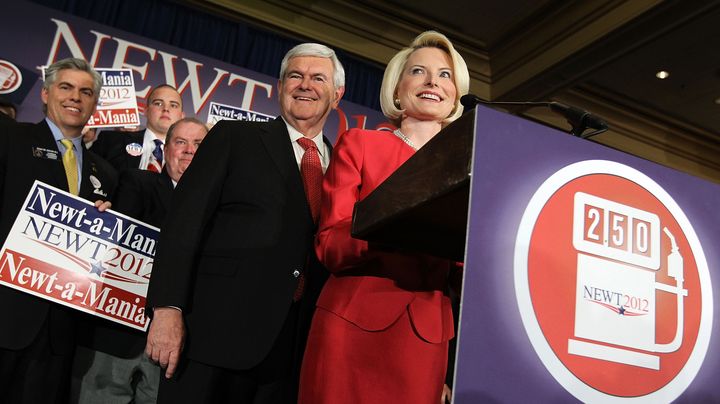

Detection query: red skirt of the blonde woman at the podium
(298, 308), (448, 404)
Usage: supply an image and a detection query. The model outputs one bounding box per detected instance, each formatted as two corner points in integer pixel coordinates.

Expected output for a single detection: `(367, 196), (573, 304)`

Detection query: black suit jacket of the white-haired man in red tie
(147, 119), (326, 369)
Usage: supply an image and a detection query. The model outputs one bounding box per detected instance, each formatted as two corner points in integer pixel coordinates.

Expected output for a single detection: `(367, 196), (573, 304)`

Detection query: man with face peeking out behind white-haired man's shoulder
(71, 118), (207, 404)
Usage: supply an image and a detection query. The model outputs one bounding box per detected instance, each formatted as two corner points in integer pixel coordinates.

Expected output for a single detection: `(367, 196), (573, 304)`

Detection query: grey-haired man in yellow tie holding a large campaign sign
(0, 59), (117, 403)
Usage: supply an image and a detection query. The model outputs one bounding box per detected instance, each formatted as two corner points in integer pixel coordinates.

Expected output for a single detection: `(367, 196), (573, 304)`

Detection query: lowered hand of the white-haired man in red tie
(145, 307), (185, 379)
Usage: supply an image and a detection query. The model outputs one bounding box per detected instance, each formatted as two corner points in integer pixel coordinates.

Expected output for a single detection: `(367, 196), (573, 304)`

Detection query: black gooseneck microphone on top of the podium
(460, 94), (609, 139)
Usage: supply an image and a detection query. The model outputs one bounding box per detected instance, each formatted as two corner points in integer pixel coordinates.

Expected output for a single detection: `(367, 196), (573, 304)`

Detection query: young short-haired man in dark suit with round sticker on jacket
(91, 84), (185, 173)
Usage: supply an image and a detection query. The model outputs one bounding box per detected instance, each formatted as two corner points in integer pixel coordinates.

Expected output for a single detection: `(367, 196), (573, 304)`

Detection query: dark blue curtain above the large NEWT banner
(30, 0), (383, 111)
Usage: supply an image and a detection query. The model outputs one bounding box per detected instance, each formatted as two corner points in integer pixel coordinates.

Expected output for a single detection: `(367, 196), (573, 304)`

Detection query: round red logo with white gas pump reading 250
(515, 161), (712, 401)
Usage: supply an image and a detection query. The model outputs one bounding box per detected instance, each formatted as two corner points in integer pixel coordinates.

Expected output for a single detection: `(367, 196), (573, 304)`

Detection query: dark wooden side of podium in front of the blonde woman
(352, 111), (475, 261)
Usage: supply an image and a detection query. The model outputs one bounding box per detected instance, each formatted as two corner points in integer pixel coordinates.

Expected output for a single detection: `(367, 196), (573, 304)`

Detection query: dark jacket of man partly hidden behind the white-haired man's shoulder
(78, 169), (173, 358)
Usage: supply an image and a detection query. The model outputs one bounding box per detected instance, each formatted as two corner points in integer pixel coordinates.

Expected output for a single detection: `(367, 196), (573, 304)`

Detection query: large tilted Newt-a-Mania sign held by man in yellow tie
(0, 181), (160, 331)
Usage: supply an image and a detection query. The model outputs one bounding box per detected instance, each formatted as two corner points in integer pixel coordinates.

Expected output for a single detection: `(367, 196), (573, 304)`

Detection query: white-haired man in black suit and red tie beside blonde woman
(146, 44), (344, 403)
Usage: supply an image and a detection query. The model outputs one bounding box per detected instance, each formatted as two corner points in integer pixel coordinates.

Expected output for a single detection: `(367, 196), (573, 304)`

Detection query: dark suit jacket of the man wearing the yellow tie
(0, 120), (117, 352)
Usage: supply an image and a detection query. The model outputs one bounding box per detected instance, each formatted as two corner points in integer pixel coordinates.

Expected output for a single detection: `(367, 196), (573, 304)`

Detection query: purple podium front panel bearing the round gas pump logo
(454, 107), (720, 404)
